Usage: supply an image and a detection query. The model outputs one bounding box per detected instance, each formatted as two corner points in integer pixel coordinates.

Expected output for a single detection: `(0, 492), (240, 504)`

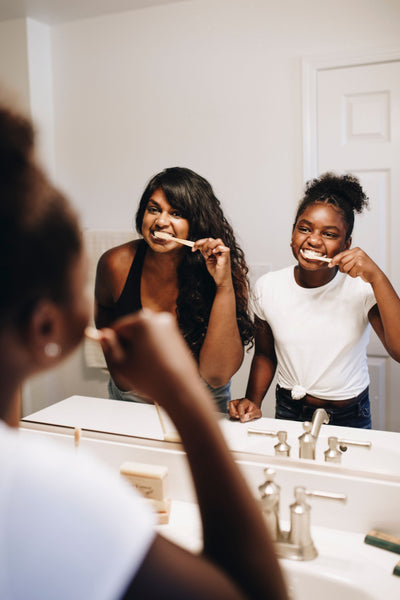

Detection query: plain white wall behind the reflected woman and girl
(0, 0), (400, 420)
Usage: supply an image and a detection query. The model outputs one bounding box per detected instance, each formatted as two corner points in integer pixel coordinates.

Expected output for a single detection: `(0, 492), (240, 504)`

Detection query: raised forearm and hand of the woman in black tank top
(193, 238), (244, 387)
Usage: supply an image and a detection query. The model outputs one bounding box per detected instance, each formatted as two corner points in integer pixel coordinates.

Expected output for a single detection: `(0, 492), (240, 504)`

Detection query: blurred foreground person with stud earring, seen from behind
(0, 107), (287, 600)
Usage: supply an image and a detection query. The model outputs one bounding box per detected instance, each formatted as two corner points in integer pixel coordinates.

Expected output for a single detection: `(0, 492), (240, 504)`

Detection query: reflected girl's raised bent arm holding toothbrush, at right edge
(330, 248), (400, 362)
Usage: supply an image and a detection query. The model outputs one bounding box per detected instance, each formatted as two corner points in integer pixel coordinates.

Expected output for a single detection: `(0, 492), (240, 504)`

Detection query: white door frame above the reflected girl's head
(301, 46), (400, 182)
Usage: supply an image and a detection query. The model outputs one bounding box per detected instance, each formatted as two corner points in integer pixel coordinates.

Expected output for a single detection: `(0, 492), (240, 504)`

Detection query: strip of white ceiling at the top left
(0, 0), (192, 25)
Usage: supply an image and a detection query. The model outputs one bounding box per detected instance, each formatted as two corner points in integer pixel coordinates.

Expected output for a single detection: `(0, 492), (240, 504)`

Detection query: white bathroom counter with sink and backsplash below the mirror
(20, 425), (400, 600)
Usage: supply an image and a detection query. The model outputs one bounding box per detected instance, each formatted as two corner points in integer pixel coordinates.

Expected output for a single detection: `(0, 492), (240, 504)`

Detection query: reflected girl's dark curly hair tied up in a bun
(293, 173), (368, 239)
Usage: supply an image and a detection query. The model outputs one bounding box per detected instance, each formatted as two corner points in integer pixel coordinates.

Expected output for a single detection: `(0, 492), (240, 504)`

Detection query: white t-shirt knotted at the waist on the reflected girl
(254, 266), (376, 400)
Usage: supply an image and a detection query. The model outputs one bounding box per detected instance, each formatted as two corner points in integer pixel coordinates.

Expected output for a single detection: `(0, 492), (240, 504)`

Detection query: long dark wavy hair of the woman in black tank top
(136, 167), (254, 358)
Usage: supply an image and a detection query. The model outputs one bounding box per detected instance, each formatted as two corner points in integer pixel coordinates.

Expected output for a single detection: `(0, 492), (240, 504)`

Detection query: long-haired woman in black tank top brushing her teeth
(95, 167), (253, 412)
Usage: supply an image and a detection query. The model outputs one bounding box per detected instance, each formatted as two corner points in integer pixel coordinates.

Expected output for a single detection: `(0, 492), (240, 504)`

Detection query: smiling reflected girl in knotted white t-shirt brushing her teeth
(229, 173), (400, 428)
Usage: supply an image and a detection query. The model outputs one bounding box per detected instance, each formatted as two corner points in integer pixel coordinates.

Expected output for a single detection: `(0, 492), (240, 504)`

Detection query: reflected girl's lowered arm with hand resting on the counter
(229, 317), (277, 422)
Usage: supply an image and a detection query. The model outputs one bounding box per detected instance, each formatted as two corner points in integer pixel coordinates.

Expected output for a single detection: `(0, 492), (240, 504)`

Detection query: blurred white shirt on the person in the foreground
(0, 422), (155, 600)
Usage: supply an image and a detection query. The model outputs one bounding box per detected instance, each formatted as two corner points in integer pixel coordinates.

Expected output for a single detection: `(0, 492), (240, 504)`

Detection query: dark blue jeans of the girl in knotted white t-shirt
(275, 385), (372, 429)
